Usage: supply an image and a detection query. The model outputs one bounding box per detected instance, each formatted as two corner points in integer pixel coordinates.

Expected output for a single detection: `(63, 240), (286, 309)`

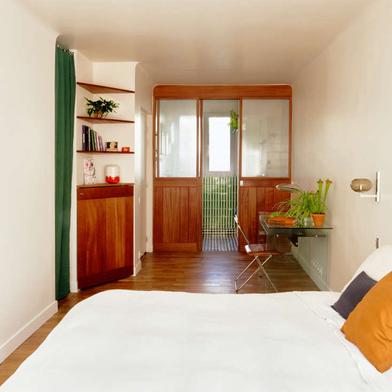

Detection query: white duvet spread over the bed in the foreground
(0, 290), (392, 392)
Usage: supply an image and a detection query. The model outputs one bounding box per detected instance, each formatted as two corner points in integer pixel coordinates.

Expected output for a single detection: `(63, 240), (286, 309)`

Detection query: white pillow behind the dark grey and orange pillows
(342, 245), (392, 291)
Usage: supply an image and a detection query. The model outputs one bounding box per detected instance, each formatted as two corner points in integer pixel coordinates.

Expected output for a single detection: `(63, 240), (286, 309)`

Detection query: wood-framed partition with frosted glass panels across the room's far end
(153, 85), (292, 252)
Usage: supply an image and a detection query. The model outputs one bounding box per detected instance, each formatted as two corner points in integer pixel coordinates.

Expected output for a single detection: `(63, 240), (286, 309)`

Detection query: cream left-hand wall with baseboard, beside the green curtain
(0, 1), (57, 362)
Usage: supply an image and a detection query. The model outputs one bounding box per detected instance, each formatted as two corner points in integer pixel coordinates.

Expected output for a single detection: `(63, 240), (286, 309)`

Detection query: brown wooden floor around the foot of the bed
(0, 252), (317, 385)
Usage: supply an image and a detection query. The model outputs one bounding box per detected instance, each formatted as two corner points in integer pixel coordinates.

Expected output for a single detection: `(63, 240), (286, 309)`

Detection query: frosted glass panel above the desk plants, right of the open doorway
(242, 99), (289, 177)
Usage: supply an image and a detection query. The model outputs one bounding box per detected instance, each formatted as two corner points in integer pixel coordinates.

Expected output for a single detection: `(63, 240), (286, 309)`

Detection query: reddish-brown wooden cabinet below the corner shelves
(77, 184), (133, 289)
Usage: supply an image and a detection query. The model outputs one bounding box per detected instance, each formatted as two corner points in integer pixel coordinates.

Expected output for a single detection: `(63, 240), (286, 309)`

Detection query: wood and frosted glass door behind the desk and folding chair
(238, 97), (291, 250)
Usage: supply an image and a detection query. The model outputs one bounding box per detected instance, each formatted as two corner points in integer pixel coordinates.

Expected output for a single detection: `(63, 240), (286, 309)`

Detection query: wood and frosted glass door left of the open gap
(153, 99), (202, 252)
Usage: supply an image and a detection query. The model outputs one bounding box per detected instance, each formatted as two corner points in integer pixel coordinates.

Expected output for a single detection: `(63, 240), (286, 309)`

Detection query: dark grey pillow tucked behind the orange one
(332, 271), (377, 319)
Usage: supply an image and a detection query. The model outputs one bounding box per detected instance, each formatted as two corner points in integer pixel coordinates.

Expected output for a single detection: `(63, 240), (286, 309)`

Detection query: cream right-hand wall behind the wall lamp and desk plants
(293, 0), (392, 289)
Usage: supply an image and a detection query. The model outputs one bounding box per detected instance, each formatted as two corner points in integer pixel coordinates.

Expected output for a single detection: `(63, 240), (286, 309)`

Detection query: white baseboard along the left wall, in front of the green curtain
(0, 301), (57, 363)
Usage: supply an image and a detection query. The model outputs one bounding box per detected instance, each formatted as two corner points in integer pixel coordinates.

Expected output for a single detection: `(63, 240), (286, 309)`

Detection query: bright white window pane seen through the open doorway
(208, 117), (231, 172)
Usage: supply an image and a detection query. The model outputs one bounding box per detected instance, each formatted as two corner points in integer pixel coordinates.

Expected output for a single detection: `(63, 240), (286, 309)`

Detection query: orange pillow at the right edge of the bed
(342, 272), (392, 372)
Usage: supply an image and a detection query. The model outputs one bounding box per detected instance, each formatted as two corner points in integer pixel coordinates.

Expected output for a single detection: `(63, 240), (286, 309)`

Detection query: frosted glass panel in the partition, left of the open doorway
(159, 99), (197, 177)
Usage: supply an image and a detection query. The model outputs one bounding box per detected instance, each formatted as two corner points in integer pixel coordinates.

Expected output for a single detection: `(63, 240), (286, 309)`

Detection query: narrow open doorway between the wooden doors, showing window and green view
(202, 99), (240, 252)
